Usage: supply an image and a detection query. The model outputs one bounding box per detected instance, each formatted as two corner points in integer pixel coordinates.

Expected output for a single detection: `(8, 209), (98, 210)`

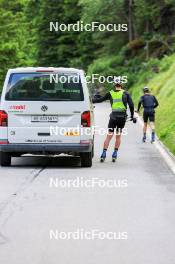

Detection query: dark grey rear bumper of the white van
(0, 143), (93, 154)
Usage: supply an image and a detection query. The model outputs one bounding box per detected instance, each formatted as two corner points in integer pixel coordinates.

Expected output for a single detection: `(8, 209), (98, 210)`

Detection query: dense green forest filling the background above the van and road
(0, 0), (175, 87)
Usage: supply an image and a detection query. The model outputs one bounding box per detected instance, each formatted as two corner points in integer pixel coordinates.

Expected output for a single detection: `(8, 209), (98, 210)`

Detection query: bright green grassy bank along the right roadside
(131, 55), (175, 154)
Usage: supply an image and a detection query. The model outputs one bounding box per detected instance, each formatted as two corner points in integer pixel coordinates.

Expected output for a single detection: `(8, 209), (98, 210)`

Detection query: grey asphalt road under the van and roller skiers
(0, 103), (175, 264)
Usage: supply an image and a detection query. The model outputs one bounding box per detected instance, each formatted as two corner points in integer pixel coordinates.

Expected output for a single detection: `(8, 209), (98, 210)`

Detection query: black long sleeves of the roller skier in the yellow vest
(92, 91), (134, 117)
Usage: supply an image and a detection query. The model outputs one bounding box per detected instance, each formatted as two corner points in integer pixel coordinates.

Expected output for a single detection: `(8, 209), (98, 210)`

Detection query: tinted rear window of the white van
(5, 73), (84, 101)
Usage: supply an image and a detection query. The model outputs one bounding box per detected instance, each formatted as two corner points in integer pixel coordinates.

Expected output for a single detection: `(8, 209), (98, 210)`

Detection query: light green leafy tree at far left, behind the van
(0, 0), (26, 89)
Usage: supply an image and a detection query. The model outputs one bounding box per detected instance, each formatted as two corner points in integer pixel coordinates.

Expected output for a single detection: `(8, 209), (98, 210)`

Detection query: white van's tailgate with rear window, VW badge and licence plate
(5, 72), (87, 144)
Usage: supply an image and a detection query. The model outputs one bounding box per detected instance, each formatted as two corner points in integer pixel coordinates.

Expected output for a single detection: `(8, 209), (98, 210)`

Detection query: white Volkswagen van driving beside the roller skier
(0, 68), (94, 167)
